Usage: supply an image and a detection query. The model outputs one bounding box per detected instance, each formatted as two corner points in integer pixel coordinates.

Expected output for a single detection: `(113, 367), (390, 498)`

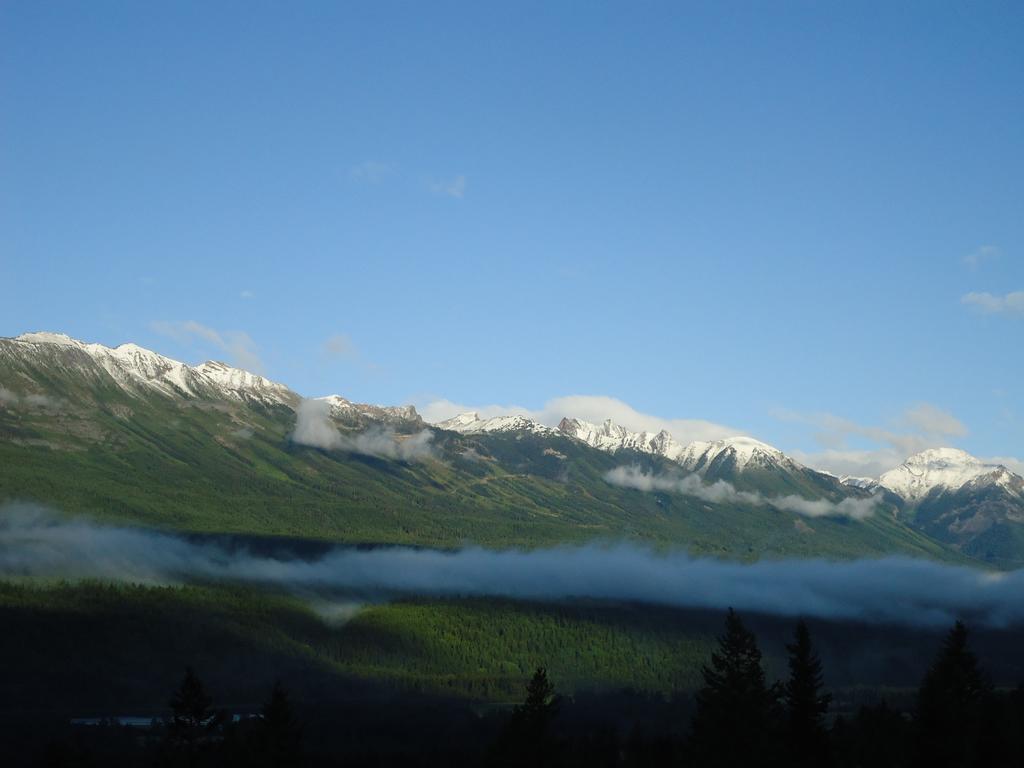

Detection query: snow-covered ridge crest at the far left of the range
(7, 332), (298, 404)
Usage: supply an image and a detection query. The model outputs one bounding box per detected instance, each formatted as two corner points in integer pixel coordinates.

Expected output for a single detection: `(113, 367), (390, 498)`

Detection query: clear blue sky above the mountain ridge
(0, 1), (1024, 479)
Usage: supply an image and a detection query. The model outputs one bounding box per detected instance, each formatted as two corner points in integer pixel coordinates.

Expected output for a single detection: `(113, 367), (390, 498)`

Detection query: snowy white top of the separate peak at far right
(879, 447), (1024, 502)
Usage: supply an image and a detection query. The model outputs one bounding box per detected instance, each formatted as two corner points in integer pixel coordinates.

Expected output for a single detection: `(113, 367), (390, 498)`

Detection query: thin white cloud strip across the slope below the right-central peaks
(604, 466), (880, 520)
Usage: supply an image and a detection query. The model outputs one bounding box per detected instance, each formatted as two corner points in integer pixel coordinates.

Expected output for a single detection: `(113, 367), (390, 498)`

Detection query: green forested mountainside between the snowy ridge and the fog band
(0, 340), (957, 559)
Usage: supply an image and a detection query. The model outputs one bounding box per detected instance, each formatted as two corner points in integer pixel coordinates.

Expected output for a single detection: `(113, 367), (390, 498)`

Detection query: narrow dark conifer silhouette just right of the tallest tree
(782, 621), (831, 766)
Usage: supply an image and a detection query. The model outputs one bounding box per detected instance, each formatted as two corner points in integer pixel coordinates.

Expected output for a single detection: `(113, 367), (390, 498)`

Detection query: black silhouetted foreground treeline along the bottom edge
(16, 610), (1024, 768)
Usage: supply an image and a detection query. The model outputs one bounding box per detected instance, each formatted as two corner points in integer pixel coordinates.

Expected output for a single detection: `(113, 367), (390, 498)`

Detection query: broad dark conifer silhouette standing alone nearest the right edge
(916, 622), (991, 768)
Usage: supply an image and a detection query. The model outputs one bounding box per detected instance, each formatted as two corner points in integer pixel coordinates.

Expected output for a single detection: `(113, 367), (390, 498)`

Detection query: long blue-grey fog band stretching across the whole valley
(0, 505), (1024, 626)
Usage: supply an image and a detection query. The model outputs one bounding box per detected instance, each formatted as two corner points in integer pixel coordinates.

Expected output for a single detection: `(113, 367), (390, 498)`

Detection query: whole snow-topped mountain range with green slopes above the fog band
(0, 333), (1024, 566)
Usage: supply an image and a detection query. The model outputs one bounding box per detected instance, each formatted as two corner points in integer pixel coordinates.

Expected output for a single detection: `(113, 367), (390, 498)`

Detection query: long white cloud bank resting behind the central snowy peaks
(417, 394), (743, 443)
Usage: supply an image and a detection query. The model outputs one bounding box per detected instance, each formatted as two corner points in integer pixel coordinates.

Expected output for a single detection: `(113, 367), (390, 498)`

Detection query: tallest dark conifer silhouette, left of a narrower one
(690, 608), (777, 766)
